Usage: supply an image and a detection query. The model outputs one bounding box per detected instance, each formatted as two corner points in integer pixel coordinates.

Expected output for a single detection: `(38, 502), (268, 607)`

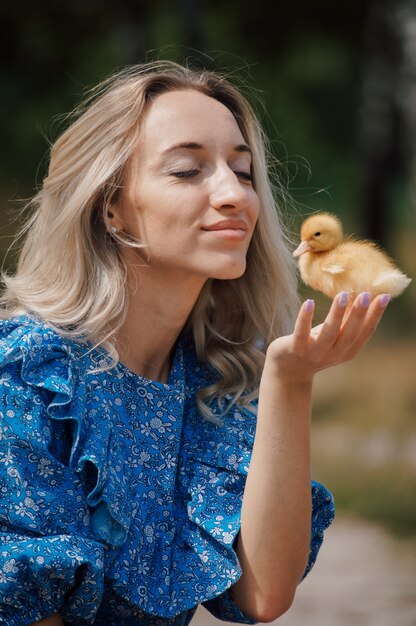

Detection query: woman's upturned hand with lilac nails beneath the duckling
(266, 292), (390, 383)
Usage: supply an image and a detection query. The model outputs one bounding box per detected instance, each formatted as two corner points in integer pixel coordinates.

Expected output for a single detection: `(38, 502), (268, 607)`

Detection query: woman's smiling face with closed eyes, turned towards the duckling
(113, 89), (259, 282)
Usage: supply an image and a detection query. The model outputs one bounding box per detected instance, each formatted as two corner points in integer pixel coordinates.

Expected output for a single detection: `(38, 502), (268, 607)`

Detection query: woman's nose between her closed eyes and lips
(210, 165), (251, 210)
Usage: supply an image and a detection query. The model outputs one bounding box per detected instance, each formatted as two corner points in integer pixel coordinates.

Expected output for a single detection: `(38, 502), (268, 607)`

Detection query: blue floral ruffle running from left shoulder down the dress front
(0, 316), (133, 546)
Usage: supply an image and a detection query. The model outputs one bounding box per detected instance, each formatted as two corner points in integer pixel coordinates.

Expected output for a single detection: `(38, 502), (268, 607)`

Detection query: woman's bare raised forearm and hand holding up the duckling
(232, 296), (388, 622)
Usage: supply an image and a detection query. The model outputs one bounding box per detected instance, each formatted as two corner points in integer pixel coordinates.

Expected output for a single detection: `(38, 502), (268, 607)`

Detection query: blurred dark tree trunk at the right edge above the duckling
(360, 0), (416, 242)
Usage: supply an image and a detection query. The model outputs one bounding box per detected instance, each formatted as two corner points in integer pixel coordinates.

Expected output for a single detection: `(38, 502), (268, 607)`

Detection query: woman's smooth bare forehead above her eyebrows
(140, 89), (244, 151)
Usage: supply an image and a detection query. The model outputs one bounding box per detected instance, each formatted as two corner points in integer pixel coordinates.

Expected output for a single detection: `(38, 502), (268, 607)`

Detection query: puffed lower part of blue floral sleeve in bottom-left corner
(0, 529), (103, 626)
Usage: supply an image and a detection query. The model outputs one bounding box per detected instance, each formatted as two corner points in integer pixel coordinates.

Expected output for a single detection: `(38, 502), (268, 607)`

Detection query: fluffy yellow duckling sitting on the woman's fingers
(293, 213), (411, 298)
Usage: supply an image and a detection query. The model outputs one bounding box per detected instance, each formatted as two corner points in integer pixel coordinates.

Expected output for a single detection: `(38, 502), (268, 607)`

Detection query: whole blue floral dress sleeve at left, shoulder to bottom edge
(0, 320), (104, 626)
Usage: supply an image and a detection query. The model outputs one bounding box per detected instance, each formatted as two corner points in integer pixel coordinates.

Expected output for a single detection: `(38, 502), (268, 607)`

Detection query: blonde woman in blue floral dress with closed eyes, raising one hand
(0, 63), (388, 626)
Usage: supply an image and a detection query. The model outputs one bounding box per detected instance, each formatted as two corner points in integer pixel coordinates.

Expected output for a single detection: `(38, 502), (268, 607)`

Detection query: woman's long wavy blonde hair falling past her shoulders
(2, 62), (298, 416)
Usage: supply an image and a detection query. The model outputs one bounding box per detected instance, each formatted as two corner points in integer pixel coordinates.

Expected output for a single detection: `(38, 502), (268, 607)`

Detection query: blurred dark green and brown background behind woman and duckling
(0, 0), (416, 537)
